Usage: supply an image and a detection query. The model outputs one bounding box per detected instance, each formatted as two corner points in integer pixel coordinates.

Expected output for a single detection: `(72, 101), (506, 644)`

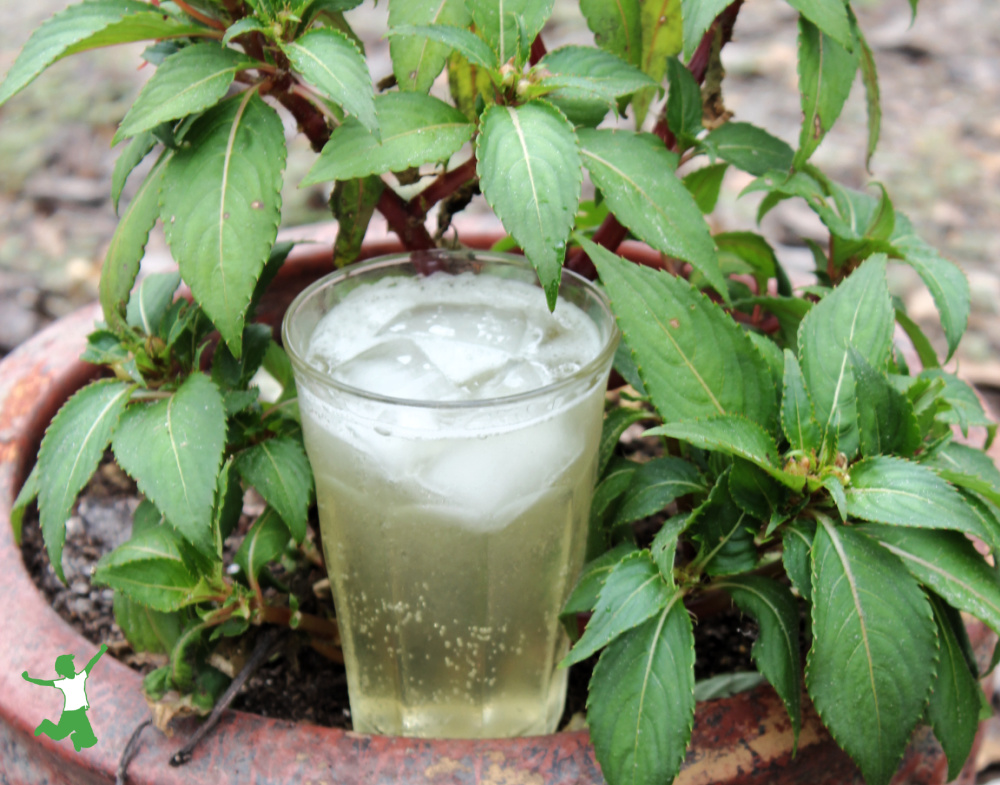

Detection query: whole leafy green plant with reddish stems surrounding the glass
(0, 0), (1000, 785)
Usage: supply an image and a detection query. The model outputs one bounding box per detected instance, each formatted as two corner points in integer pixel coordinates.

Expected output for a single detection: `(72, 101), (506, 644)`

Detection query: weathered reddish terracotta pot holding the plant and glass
(0, 235), (993, 785)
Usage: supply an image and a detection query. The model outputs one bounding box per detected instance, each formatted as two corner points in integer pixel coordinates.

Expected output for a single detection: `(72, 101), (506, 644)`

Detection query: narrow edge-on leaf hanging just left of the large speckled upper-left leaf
(98, 151), (174, 330)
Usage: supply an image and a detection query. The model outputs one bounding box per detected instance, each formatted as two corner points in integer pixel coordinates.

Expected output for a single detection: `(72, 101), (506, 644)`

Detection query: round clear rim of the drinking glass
(281, 248), (621, 411)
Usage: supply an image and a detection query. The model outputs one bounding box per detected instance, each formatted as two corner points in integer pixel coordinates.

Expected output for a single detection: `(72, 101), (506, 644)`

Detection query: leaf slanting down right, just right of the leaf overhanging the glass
(579, 128), (727, 296)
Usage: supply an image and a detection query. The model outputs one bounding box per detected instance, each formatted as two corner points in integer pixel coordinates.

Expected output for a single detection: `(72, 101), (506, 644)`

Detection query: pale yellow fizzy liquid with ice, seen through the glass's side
(299, 272), (605, 738)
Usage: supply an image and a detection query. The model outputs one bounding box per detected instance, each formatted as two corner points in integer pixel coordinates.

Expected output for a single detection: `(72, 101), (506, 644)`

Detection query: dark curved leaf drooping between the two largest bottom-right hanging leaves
(716, 575), (802, 745)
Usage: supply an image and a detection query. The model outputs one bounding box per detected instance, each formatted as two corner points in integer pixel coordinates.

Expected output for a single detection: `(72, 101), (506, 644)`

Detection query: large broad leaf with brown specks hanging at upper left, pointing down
(161, 92), (285, 356)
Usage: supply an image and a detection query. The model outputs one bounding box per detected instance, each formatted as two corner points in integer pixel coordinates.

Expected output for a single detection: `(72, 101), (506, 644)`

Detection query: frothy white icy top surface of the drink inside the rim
(307, 272), (601, 401)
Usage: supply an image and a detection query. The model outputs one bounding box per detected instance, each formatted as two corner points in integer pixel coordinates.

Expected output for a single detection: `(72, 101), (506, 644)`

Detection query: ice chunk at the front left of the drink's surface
(333, 338), (461, 401)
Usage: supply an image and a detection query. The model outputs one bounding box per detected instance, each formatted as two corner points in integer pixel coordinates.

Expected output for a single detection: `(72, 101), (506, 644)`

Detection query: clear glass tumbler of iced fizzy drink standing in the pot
(282, 251), (619, 738)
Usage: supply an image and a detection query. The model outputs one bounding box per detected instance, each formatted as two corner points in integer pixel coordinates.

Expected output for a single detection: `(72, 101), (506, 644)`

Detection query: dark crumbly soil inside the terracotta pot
(21, 450), (757, 729)
